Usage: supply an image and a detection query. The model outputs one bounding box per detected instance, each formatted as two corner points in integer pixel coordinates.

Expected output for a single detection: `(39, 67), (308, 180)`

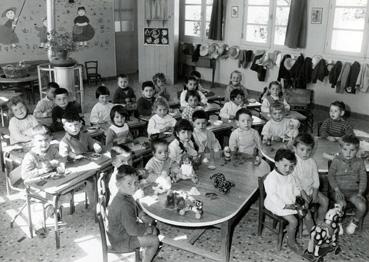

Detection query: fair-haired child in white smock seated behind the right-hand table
(261, 102), (298, 143)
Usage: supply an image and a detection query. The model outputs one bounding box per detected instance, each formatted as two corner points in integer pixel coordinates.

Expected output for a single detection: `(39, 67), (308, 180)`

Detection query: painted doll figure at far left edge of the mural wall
(0, 7), (19, 47)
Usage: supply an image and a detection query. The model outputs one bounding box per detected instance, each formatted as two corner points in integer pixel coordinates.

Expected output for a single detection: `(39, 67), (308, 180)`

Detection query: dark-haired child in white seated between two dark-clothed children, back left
(90, 86), (113, 127)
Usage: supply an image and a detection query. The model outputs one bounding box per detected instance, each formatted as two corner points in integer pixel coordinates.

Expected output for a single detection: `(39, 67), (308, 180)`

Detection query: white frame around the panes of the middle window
(241, 0), (288, 50)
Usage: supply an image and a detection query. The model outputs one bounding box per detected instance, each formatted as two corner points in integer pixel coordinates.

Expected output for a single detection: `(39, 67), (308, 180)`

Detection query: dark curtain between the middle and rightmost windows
(284, 0), (308, 48)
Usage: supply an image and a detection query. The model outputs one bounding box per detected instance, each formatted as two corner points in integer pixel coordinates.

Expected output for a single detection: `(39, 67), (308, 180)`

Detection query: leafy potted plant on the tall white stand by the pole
(48, 30), (76, 67)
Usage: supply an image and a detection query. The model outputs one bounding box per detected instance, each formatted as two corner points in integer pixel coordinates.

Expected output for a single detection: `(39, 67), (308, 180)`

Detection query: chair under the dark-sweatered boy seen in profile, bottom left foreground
(96, 170), (140, 262)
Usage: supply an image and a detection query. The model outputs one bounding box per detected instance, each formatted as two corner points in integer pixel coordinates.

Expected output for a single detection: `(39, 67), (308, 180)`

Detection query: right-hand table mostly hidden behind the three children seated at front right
(261, 137), (369, 173)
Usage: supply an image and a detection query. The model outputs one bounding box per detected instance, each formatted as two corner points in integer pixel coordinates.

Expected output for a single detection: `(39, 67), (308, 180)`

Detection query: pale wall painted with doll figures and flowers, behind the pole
(0, 0), (116, 76)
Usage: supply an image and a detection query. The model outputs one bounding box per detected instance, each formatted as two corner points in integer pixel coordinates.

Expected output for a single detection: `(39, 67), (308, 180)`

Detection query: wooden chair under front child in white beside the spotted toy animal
(258, 175), (288, 250)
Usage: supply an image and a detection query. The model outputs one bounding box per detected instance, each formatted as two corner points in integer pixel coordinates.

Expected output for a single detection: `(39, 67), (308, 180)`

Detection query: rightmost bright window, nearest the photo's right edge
(327, 0), (368, 54)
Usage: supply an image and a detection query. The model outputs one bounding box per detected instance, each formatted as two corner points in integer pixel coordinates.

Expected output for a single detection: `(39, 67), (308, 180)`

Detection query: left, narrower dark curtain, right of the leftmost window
(208, 0), (227, 40)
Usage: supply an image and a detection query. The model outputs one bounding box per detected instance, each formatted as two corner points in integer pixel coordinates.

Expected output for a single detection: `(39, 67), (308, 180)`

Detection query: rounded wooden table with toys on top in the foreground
(140, 161), (270, 262)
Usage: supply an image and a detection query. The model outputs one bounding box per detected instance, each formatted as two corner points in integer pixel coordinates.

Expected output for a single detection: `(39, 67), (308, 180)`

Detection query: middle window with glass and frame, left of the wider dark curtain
(244, 0), (291, 47)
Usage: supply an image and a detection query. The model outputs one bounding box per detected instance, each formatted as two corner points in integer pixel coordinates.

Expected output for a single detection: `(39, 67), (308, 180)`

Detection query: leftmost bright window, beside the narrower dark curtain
(183, 0), (213, 40)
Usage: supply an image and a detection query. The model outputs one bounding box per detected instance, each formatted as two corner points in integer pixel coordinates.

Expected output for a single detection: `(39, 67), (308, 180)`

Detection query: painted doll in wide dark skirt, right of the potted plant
(73, 6), (95, 46)
